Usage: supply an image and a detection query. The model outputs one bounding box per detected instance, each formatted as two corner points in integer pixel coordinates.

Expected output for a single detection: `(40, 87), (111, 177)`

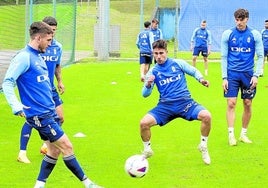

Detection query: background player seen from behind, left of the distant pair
(136, 21), (154, 82)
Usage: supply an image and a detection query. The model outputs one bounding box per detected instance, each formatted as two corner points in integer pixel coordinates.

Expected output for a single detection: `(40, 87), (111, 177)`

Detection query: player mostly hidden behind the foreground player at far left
(17, 16), (64, 163)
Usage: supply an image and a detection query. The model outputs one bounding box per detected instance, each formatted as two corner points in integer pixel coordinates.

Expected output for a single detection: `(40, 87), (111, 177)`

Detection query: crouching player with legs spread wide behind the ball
(140, 40), (211, 165)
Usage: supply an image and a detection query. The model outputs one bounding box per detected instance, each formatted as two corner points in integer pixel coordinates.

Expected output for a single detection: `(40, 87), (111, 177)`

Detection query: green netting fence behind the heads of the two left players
(0, 0), (77, 65)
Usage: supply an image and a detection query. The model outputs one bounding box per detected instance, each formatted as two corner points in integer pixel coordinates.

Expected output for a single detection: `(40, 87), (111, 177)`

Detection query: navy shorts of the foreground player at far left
(26, 112), (64, 142)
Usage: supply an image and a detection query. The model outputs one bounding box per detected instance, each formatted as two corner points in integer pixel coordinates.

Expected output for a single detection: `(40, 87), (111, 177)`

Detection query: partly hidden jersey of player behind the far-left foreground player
(41, 39), (62, 89)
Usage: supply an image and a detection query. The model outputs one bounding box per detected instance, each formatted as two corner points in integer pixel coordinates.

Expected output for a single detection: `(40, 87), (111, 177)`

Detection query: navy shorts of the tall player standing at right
(224, 71), (256, 99)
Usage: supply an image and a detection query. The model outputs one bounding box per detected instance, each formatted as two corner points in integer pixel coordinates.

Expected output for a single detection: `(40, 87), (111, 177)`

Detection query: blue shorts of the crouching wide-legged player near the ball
(148, 98), (205, 126)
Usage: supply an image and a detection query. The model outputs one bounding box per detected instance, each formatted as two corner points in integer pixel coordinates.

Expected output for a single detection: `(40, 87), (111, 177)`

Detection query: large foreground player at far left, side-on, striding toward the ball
(2, 22), (102, 188)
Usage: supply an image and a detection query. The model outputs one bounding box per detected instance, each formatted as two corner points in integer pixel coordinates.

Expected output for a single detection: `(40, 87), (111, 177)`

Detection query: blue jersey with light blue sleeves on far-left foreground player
(2, 45), (55, 118)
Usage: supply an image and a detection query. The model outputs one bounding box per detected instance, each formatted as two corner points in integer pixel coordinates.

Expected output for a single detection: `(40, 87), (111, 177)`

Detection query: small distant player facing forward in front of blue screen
(190, 20), (211, 76)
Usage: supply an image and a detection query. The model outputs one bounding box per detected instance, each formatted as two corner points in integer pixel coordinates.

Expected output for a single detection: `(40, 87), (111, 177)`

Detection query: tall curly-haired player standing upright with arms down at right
(221, 9), (263, 146)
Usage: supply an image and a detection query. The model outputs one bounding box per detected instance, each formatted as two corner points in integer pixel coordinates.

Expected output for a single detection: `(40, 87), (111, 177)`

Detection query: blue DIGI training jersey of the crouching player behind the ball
(142, 58), (203, 102)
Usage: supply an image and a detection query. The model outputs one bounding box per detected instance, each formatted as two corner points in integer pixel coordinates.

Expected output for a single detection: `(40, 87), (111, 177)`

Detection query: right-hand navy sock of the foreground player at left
(63, 155), (87, 181)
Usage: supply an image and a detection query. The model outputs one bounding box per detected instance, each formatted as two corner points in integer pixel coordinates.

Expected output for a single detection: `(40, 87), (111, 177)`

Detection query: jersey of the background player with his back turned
(136, 29), (154, 54)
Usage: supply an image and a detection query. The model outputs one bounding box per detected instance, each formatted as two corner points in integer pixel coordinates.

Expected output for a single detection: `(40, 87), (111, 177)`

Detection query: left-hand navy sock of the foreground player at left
(37, 155), (57, 182)
